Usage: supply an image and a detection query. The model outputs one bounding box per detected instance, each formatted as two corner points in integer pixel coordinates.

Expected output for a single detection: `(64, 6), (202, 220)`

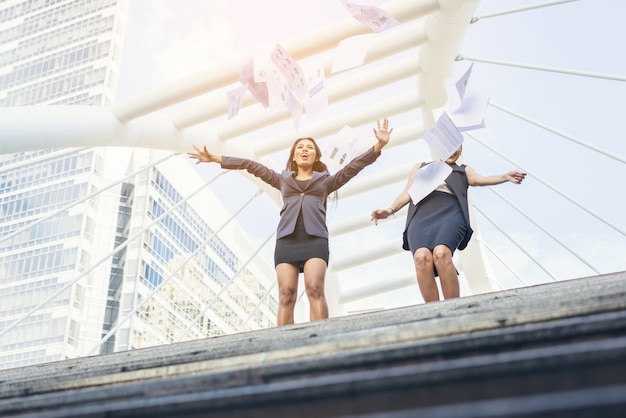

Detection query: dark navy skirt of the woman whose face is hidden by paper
(407, 191), (467, 254)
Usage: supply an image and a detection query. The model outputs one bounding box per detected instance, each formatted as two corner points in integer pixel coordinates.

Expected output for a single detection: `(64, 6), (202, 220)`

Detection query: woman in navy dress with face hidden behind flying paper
(372, 147), (526, 302)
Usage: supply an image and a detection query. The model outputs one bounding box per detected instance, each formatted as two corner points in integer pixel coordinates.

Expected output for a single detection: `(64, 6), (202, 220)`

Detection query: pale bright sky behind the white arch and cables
(117, 0), (626, 310)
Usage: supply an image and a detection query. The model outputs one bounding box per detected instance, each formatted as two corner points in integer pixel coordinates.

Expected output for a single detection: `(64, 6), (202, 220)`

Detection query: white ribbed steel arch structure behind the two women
(0, 0), (620, 315)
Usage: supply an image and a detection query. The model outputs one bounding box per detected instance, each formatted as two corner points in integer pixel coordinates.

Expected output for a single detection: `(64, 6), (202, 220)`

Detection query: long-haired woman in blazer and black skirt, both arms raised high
(189, 119), (393, 326)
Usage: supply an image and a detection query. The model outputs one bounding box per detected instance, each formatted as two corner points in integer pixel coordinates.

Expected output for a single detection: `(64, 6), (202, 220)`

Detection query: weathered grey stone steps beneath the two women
(0, 272), (626, 418)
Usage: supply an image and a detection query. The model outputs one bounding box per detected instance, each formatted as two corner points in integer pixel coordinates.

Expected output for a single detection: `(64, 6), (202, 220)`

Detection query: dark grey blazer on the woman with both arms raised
(222, 147), (381, 239)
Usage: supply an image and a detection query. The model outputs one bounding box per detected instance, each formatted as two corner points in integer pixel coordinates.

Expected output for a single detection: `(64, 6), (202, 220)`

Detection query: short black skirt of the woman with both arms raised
(274, 213), (329, 273)
